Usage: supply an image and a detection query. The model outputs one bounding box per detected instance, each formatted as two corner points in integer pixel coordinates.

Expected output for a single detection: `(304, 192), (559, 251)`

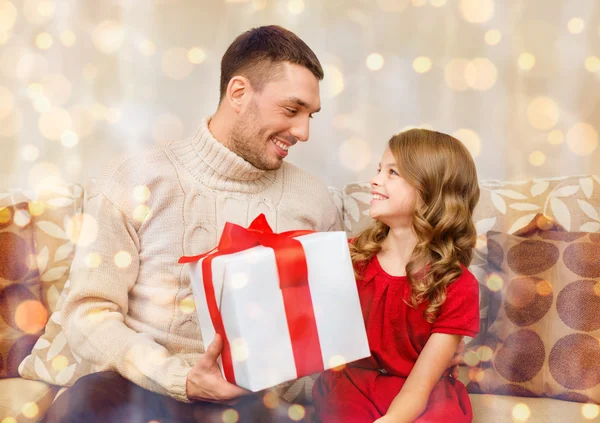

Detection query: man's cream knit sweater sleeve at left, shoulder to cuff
(63, 193), (191, 402)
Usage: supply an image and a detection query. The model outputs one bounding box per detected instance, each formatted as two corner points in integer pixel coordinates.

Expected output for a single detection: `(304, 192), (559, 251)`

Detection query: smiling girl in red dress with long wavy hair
(313, 129), (479, 423)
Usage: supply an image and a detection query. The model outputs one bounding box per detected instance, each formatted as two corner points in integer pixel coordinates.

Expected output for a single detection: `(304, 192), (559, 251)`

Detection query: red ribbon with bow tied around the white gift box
(179, 214), (324, 383)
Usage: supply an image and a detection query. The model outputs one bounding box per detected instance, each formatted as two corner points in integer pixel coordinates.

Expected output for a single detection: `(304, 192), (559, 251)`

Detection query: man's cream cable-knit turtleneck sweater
(63, 118), (341, 401)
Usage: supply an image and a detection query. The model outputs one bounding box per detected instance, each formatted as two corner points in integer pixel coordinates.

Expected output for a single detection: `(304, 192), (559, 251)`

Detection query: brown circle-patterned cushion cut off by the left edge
(0, 202), (42, 378)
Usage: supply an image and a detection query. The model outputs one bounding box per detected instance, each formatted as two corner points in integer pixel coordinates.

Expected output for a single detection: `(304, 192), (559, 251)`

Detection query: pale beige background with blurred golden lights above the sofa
(0, 0), (600, 188)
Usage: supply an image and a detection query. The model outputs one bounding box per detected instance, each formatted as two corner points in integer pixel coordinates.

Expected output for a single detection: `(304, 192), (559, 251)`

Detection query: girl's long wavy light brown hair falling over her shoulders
(350, 129), (479, 322)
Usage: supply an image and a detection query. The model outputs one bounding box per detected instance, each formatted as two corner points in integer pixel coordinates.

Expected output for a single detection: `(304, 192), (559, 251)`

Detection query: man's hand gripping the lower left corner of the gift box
(186, 335), (250, 402)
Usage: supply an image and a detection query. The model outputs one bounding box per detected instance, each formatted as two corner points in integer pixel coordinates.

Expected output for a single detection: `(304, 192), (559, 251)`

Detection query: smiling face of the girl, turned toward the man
(370, 148), (417, 228)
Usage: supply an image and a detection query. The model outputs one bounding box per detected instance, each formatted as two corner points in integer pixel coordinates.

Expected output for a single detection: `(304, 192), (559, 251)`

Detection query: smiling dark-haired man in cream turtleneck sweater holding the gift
(46, 26), (341, 423)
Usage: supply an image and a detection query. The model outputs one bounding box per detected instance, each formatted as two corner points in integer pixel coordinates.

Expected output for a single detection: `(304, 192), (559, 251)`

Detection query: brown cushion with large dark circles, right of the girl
(466, 231), (600, 403)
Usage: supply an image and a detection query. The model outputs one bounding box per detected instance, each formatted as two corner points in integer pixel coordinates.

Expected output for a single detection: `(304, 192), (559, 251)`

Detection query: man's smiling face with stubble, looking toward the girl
(230, 63), (321, 170)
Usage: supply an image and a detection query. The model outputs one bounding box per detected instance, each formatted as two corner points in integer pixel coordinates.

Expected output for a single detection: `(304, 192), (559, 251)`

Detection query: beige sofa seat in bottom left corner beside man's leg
(0, 378), (59, 423)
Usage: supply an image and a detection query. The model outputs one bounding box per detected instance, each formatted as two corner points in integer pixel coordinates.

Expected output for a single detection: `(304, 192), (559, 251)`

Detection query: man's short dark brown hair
(219, 25), (323, 100)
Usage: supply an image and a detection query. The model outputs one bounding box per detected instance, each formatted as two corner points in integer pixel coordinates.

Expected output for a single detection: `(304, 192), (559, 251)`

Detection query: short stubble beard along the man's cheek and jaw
(230, 102), (283, 170)
